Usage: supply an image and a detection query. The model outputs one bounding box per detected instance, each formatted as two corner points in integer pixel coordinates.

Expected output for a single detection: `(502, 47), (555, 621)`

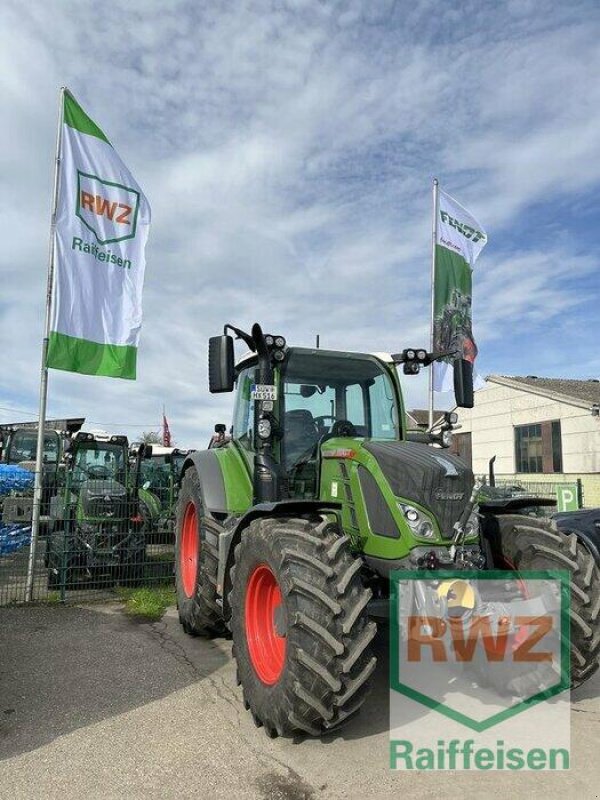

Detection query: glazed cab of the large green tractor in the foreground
(233, 347), (404, 498)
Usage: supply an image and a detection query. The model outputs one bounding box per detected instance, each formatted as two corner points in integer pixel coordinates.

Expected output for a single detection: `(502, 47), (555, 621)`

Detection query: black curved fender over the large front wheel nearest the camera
(217, 500), (342, 619)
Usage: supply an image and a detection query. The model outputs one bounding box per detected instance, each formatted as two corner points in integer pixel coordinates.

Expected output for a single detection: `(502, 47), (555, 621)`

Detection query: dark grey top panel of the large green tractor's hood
(363, 441), (474, 537)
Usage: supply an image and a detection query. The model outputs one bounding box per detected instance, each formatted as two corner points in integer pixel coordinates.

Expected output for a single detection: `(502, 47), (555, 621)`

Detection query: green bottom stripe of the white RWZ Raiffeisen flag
(46, 331), (137, 380)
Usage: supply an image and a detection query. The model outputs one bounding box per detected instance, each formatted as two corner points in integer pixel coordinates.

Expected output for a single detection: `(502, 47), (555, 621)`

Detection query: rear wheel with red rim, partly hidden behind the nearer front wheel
(175, 467), (225, 636)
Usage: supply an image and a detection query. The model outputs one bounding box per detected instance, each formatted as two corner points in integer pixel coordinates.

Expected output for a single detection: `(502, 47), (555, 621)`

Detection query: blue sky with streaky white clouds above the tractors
(0, 0), (600, 447)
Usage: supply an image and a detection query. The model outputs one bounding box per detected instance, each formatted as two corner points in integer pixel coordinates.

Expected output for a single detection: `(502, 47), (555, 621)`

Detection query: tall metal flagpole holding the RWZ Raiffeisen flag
(25, 86), (67, 603)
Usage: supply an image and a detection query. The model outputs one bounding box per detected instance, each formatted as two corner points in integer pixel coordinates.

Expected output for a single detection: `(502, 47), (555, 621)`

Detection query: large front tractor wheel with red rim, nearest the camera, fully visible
(230, 516), (377, 736)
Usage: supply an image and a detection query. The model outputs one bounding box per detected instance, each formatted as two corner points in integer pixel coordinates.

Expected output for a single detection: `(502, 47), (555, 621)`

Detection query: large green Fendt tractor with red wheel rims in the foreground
(175, 324), (600, 736)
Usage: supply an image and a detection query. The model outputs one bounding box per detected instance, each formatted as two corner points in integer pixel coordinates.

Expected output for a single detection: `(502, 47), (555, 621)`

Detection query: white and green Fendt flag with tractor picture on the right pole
(433, 190), (487, 392)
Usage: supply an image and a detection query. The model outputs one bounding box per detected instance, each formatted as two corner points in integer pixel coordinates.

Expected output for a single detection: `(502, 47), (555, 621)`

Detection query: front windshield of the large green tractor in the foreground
(282, 350), (399, 471)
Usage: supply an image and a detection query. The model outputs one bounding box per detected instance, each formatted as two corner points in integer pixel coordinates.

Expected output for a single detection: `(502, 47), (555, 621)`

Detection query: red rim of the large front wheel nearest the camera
(245, 564), (287, 686)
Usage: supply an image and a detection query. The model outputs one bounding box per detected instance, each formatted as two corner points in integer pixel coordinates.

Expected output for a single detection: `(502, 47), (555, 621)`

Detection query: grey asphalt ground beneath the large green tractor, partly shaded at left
(0, 605), (600, 800)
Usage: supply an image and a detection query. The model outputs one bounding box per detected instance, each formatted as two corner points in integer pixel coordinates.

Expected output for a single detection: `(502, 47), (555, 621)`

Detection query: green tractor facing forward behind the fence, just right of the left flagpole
(46, 431), (151, 589)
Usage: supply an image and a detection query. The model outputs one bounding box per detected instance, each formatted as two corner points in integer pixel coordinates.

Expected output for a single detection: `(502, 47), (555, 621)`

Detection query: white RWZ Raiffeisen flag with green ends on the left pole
(47, 92), (150, 379)
